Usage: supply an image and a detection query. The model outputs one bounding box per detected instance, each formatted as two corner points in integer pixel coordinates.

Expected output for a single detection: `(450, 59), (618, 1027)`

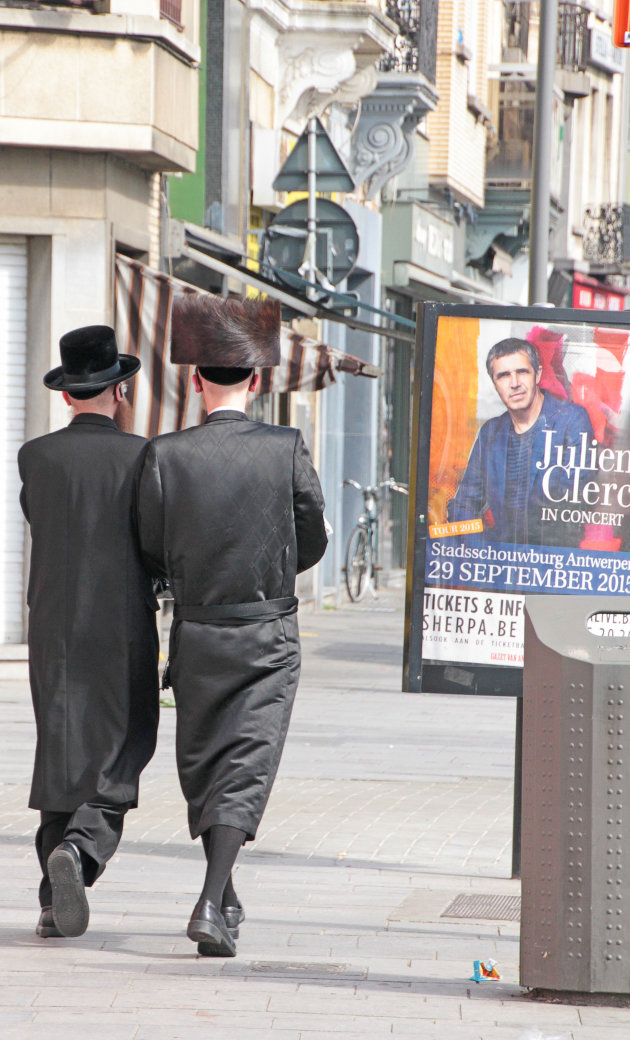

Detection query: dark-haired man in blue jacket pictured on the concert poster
(447, 337), (594, 547)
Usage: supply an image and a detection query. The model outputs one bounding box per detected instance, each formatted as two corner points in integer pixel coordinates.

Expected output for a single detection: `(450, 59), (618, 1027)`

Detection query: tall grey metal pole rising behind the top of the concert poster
(529, 0), (558, 306)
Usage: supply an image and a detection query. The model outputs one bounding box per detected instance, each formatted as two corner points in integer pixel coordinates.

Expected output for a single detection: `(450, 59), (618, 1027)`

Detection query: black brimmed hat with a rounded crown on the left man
(44, 326), (140, 396)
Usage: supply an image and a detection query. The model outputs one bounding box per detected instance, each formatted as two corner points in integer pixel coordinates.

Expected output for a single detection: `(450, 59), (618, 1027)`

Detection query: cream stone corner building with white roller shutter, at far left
(0, 0), (200, 644)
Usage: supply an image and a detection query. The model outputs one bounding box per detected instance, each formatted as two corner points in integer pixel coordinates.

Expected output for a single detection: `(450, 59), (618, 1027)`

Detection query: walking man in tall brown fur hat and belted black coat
(138, 295), (326, 957)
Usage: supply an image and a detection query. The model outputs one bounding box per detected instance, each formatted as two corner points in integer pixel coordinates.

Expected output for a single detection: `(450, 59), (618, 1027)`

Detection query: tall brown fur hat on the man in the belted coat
(170, 293), (281, 368)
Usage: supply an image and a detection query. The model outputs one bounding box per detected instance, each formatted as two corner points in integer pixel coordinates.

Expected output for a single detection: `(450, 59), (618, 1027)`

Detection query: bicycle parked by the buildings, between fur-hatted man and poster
(341, 477), (409, 603)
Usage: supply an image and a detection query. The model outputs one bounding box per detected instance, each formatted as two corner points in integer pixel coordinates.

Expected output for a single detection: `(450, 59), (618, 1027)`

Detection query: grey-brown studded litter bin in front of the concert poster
(521, 596), (630, 994)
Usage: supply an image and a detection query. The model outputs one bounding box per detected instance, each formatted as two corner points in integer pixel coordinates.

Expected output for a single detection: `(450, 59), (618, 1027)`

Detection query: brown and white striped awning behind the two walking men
(115, 255), (374, 437)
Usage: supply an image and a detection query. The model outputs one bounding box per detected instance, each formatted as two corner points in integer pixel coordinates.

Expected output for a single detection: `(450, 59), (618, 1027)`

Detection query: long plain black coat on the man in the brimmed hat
(18, 414), (159, 812)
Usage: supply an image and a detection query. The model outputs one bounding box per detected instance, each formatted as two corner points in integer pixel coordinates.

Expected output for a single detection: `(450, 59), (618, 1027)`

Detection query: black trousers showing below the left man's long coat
(35, 802), (129, 907)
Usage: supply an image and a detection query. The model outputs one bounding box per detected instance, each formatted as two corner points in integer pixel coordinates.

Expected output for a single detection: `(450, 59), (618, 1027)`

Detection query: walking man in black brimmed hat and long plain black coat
(18, 326), (159, 938)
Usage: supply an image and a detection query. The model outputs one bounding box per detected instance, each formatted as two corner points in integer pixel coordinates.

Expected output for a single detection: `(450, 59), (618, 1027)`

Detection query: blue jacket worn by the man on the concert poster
(447, 391), (594, 546)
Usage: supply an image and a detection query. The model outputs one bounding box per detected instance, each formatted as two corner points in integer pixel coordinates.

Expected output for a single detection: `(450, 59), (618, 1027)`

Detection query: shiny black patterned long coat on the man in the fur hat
(138, 411), (326, 838)
